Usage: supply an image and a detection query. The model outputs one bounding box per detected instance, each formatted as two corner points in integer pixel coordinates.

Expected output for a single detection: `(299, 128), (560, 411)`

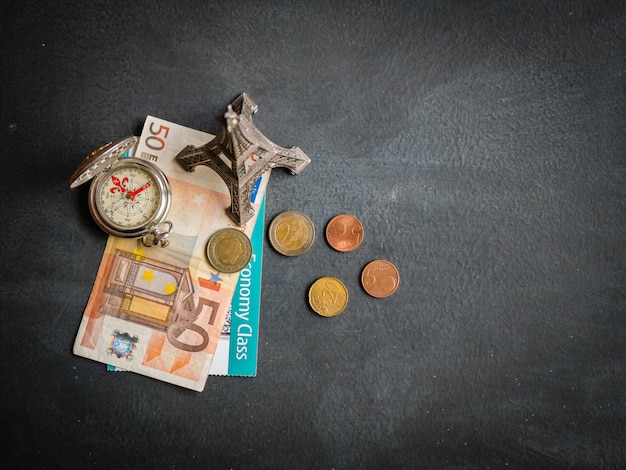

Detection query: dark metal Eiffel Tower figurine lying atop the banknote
(176, 93), (311, 226)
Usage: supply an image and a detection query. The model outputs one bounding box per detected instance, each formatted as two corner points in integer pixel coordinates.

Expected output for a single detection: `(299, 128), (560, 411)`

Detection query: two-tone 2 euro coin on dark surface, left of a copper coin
(269, 211), (315, 256)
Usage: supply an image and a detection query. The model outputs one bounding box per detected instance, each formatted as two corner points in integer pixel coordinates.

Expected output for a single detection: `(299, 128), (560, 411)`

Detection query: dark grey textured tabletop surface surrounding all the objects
(0, 0), (626, 469)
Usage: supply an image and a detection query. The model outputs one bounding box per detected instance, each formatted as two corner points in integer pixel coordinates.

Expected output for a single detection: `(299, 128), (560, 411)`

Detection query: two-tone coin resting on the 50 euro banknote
(206, 228), (252, 273)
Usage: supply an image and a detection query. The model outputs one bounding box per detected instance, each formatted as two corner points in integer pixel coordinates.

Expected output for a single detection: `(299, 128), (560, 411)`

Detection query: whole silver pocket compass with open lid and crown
(69, 136), (172, 247)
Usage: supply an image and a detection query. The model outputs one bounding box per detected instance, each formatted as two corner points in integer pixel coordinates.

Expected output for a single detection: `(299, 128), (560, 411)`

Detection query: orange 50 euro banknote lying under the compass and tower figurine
(73, 116), (270, 391)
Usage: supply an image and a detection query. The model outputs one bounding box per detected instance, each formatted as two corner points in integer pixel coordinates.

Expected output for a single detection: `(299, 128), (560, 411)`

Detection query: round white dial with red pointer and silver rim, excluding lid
(90, 159), (169, 237)
